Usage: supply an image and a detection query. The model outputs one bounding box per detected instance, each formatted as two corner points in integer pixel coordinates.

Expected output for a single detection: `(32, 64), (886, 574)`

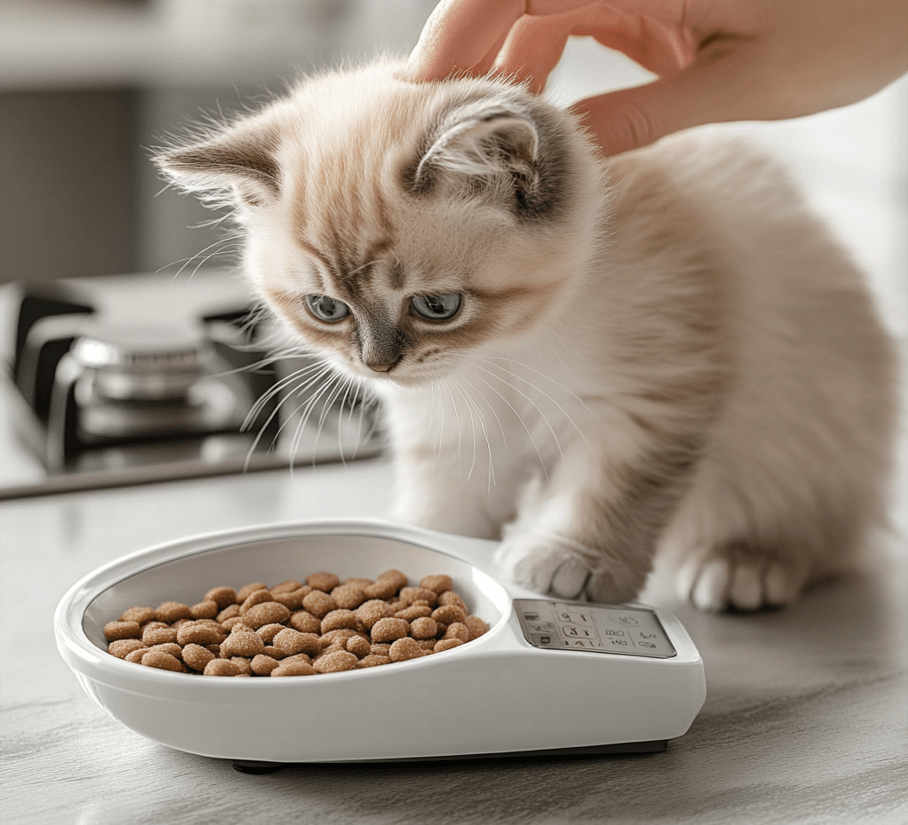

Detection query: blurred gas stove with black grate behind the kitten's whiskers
(0, 270), (382, 499)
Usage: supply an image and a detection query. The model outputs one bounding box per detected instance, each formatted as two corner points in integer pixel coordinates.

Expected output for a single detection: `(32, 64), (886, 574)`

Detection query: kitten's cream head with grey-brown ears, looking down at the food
(156, 58), (604, 384)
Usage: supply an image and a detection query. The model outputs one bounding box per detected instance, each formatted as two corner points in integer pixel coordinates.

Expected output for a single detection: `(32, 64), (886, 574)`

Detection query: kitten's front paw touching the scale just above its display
(495, 535), (645, 602)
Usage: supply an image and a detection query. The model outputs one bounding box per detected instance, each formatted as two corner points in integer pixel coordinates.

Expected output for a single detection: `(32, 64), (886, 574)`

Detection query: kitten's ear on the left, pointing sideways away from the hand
(153, 131), (280, 206)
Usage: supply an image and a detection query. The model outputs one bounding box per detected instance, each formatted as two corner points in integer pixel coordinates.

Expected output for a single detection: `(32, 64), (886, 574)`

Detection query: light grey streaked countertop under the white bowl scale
(0, 459), (908, 825)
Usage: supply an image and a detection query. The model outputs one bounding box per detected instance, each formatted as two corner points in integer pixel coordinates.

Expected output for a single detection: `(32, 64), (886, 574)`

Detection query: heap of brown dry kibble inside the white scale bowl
(104, 570), (489, 676)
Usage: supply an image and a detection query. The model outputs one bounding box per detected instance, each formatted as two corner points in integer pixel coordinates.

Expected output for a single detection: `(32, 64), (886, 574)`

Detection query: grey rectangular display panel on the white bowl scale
(514, 599), (677, 659)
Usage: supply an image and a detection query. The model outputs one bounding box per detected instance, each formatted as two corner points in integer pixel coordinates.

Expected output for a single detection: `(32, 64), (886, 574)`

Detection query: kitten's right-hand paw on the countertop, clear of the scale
(677, 556), (801, 613)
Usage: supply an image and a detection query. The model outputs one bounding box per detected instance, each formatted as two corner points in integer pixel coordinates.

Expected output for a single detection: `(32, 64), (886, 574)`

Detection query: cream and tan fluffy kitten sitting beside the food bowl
(157, 62), (895, 610)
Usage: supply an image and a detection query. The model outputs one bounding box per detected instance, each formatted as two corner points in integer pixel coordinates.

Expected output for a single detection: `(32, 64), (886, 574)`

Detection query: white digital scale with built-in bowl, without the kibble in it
(54, 520), (706, 772)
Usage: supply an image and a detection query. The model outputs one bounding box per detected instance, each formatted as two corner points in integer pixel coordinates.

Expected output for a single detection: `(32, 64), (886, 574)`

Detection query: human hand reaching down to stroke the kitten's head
(406, 0), (908, 155)
